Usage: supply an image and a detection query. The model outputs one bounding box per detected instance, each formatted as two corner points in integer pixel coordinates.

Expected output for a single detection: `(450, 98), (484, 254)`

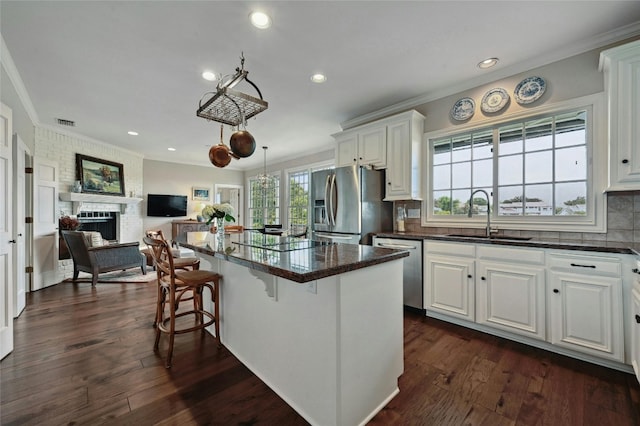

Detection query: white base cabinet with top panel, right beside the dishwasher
(424, 242), (475, 321)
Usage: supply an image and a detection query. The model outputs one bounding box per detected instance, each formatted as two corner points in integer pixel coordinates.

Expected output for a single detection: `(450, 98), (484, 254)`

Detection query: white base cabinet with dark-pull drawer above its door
(547, 253), (624, 362)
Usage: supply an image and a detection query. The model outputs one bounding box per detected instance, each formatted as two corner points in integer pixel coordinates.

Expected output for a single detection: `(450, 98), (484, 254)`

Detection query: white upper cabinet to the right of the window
(600, 40), (640, 191)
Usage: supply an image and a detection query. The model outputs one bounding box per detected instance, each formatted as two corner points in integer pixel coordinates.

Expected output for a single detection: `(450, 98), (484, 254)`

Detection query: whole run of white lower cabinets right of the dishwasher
(424, 241), (640, 368)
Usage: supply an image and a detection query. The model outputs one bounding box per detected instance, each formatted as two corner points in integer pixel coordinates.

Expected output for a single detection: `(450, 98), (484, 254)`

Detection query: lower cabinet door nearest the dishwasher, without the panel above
(424, 255), (475, 321)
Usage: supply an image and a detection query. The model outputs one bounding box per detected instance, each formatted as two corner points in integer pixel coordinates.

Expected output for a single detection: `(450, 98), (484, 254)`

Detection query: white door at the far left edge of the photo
(0, 103), (14, 359)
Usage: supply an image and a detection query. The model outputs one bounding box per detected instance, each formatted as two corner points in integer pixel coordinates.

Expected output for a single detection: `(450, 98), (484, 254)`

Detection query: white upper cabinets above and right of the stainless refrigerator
(333, 111), (424, 201)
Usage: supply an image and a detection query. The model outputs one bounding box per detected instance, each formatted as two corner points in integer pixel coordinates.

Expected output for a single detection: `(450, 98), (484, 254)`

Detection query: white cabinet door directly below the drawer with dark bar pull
(548, 272), (624, 362)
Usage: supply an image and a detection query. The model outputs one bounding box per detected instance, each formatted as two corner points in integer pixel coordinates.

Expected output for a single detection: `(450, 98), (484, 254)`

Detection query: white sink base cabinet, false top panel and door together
(475, 245), (546, 340)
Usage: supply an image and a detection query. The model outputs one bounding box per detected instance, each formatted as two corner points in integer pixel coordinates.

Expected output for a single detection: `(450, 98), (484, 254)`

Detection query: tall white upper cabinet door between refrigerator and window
(385, 121), (412, 200)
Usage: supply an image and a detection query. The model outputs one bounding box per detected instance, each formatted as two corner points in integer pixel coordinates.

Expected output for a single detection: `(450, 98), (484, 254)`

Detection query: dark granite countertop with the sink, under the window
(375, 232), (640, 255)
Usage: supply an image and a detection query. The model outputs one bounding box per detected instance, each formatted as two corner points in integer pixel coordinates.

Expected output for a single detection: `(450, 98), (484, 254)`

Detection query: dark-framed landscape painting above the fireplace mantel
(76, 154), (124, 197)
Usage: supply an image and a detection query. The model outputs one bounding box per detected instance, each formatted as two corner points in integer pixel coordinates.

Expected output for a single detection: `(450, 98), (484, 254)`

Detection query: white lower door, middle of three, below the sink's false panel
(476, 262), (545, 340)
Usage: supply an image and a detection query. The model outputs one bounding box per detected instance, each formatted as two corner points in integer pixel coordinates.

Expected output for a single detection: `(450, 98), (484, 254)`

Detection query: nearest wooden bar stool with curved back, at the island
(144, 237), (222, 368)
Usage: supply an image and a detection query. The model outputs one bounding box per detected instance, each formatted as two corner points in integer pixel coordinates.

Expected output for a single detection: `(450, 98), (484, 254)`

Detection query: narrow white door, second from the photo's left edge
(13, 133), (27, 317)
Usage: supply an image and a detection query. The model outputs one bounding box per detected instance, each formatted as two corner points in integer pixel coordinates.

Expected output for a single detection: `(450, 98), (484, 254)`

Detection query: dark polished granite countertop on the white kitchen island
(177, 231), (409, 283)
